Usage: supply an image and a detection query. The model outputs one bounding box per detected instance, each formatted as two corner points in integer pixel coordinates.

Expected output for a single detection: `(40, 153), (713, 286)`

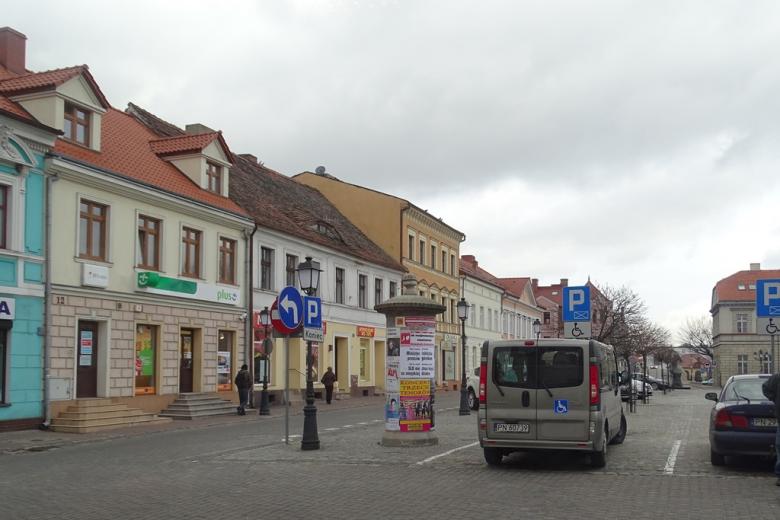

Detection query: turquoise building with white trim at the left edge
(0, 27), (58, 430)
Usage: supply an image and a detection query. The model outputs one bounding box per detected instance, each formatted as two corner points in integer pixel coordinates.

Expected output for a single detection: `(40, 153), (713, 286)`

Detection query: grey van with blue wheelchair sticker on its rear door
(478, 339), (627, 467)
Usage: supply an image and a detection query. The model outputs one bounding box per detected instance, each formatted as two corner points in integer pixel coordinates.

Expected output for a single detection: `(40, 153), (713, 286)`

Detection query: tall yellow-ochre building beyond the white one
(293, 172), (466, 387)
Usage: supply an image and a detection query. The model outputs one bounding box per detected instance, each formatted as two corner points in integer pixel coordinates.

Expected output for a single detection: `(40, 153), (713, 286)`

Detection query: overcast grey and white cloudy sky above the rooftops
(7, 0), (780, 338)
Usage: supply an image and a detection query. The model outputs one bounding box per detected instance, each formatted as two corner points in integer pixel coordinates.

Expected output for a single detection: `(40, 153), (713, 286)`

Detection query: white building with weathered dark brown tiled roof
(231, 154), (405, 401)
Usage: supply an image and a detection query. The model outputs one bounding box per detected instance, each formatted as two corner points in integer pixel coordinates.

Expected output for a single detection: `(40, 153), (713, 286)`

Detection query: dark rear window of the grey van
(493, 346), (583, 388)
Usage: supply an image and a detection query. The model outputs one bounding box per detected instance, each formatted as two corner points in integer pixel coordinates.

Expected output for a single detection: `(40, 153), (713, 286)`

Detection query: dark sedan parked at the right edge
(705, 374), (777, 466)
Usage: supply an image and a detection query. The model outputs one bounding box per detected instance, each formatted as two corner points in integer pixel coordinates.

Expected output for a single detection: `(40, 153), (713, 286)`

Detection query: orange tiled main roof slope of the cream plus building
(55, 108), (247, 216)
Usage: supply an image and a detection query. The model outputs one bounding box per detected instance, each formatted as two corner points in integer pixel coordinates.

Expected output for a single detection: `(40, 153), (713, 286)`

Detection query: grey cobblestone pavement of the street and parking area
(0, 388), (780, 520)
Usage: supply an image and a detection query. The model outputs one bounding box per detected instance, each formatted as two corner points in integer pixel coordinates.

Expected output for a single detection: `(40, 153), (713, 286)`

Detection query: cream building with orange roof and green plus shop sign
(11, 67), (253, 416)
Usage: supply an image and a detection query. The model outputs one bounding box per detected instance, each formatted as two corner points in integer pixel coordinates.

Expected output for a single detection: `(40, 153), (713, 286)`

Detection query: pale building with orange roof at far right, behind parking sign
(710, 264), (780, 385)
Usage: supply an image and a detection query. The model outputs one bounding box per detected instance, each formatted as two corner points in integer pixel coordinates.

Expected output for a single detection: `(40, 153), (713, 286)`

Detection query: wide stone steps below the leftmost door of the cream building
(50, 399), (171, 433)
